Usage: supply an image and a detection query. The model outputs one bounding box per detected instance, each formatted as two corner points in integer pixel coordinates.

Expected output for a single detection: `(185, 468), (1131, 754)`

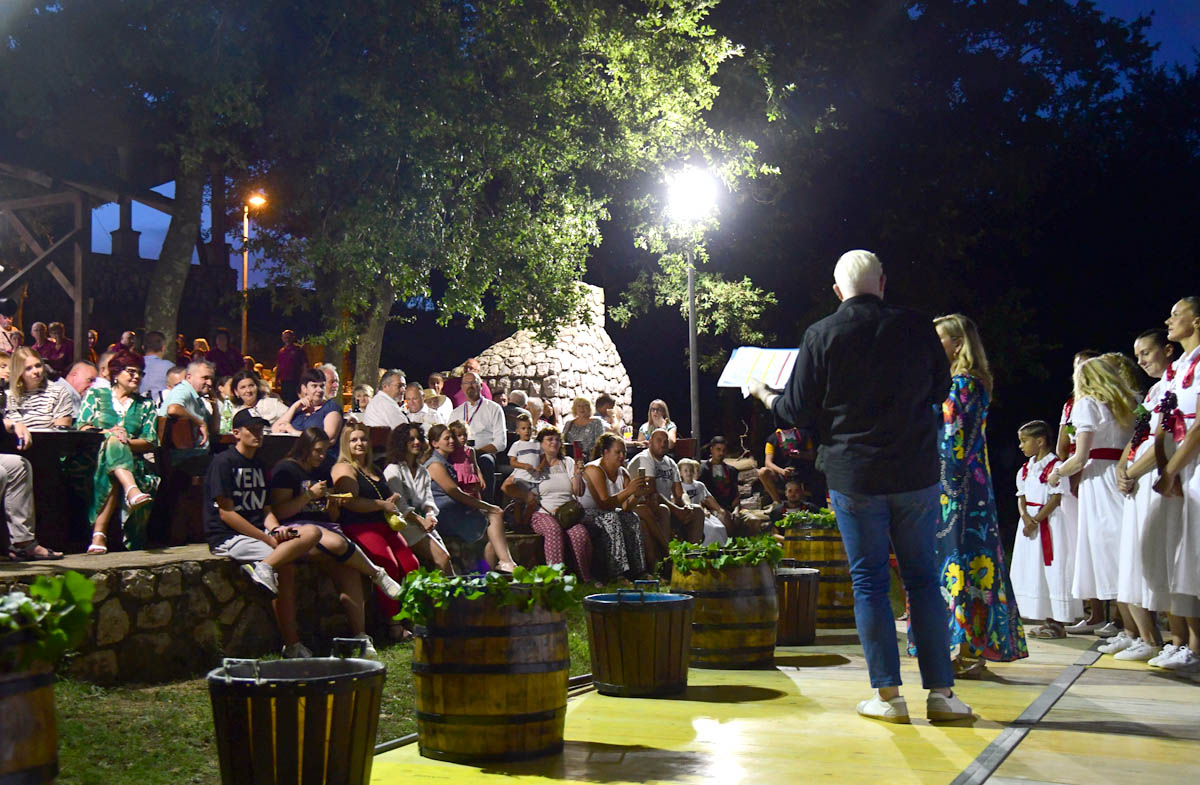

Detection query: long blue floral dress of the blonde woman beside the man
(908, 374), (1030, 663)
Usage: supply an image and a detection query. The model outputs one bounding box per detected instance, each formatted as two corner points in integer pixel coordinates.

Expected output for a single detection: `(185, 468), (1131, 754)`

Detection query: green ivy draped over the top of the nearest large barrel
(396, 564), (580, 624)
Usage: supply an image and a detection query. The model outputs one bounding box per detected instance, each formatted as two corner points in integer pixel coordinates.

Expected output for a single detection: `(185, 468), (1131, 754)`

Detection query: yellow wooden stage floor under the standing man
(371, 630), (1200, 785)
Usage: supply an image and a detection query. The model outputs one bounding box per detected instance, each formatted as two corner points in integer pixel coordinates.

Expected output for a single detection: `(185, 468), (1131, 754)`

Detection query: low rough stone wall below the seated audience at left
(0, 545), (364, 684)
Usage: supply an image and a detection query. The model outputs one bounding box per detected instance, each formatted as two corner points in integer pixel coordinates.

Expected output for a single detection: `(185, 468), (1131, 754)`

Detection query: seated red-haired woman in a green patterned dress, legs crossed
(78, 352), (158, 553)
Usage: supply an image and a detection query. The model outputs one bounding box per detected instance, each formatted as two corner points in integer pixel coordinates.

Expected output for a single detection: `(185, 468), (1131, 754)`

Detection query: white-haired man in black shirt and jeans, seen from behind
(750, 251), (972, 723)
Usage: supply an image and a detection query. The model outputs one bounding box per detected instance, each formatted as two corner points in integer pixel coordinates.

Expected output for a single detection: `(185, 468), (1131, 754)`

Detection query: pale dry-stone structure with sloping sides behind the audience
(468, 283), (634, 423)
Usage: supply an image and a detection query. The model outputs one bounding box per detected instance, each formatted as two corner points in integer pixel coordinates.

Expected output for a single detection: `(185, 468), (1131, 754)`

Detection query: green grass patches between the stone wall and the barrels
(54, 587), (604, 785)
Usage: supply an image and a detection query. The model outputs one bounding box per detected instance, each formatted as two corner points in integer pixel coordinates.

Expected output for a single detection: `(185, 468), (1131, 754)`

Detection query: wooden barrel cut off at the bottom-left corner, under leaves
(0, 667), (59, 785)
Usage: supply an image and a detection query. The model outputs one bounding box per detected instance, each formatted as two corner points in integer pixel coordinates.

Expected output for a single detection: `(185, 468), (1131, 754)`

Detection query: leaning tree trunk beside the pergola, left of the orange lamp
(145, 167), (205, 347)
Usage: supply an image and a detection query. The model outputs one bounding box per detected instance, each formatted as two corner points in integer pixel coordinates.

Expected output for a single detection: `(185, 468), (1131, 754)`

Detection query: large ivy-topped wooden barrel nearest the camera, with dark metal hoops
(413, 598), (570, 762)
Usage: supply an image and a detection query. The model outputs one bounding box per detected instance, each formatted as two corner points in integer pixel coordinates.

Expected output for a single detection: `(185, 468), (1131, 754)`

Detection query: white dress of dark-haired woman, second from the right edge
(1117, 378), (1182, 611)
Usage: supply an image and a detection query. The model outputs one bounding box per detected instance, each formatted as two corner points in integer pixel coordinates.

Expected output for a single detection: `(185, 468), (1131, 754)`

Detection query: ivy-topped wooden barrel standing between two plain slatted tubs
(671, 562), (779, 669)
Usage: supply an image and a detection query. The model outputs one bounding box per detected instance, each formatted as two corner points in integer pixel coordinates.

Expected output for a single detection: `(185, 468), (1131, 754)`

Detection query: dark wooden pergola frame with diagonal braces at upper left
(0, 161), (175, 360)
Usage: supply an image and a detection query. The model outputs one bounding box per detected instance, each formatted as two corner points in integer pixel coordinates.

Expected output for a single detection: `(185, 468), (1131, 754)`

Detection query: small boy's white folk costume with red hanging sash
(1010, 453), (1084, 623)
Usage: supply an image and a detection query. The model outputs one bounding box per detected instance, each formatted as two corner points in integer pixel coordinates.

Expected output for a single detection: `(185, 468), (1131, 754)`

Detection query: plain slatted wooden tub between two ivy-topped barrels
(583, 591), (695, 697)
